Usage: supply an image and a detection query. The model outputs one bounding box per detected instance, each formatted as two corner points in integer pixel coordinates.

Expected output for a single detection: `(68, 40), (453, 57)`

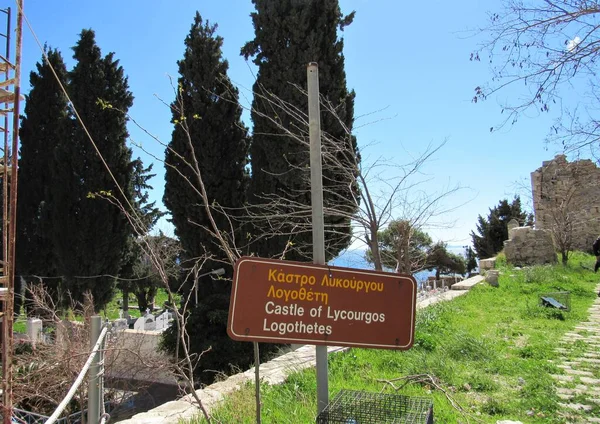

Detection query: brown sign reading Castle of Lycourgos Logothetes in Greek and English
(227, 257), (417, 349)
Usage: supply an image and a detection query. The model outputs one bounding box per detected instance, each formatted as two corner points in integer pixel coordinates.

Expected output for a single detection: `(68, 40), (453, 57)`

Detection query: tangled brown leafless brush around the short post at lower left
(13, 284), (168, 415)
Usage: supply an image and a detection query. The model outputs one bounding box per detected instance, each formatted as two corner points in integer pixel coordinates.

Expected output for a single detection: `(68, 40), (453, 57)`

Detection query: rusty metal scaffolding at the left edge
(0, 0), (23, 424)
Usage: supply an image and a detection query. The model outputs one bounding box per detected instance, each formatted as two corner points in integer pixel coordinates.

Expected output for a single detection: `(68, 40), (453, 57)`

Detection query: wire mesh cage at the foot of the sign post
(316, 390), (433, 424)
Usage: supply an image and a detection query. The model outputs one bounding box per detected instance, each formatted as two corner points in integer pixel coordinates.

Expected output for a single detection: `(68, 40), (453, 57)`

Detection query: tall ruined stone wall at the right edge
(531, 155), (600, 251)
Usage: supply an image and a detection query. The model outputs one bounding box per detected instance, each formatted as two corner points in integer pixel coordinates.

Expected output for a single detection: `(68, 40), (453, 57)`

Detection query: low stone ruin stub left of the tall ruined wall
(504, 219), (557, 266)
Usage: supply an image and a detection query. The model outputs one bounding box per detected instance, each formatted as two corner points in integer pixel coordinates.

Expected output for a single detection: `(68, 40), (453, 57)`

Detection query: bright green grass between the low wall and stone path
(189, 253), (600, 423)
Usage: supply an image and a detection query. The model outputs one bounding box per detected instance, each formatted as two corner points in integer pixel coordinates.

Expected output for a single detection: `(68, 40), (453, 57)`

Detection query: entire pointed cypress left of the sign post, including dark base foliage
(163, 13), (252, 376)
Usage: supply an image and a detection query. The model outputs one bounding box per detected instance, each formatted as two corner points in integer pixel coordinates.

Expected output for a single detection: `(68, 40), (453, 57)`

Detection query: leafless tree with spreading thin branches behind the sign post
(226, 85), (463, 270)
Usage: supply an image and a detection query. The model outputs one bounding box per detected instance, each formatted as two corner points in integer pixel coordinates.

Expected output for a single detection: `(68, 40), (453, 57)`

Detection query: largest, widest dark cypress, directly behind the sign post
(242, 0), (359, 259)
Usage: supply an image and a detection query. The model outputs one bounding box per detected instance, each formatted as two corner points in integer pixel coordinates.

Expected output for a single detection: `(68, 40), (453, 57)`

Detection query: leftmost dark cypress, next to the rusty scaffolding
(16, 49), (68, 299)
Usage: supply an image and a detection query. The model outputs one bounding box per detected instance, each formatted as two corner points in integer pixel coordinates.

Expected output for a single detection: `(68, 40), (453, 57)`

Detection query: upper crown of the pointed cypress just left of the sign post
(163, 13), (248, 257)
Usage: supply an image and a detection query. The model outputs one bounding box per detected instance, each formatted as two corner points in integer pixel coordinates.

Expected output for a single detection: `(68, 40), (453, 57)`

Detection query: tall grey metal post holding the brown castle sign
(306, 62), (329, 414)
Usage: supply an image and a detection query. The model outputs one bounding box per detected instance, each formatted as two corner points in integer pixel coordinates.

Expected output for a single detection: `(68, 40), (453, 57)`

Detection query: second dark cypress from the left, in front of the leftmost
(51, 30), (133, 309)
